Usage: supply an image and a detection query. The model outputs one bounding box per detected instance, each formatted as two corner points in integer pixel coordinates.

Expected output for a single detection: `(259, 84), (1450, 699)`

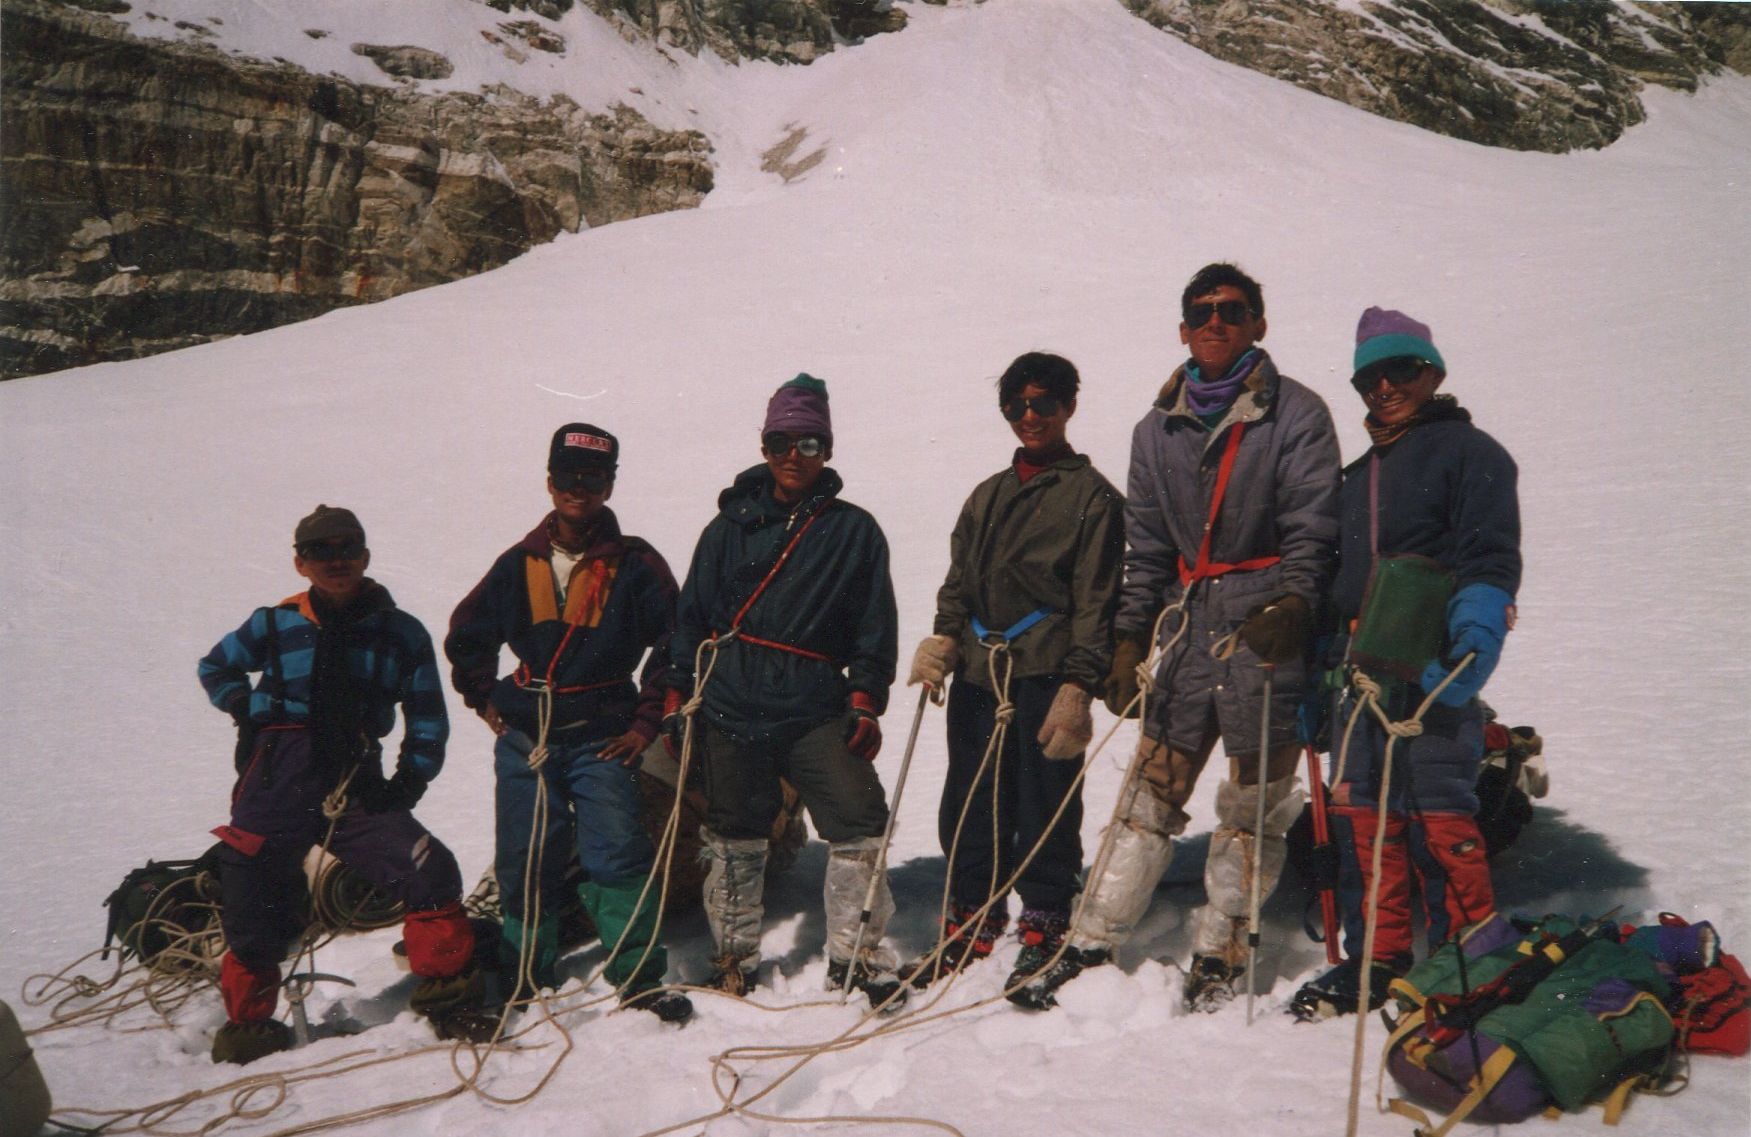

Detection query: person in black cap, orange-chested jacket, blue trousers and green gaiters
(445, 422), (693, 1021)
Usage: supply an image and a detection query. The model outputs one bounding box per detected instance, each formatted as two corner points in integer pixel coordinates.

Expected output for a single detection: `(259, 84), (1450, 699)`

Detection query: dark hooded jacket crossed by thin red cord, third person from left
(669, 466), (900, 739)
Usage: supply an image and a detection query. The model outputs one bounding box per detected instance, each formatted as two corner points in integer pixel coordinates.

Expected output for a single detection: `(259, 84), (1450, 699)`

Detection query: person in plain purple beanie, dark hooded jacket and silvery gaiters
(671, 375), (905, 1007)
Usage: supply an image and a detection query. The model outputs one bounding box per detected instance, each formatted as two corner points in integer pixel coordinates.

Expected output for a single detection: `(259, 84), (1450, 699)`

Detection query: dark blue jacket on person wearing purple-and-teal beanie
(1331, 398), (1520, 629)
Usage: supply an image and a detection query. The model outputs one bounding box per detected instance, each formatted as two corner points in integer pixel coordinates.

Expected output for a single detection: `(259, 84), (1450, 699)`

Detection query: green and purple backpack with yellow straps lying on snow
(1383, 915), (1677, 1137)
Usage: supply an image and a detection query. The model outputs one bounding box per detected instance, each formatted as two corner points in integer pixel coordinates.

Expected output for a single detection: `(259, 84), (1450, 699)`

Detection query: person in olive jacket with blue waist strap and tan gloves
(907, 352), (1124, 999)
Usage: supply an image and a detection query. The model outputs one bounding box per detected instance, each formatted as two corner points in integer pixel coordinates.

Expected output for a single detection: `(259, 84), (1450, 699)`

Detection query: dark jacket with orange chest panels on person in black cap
(443, 508), (676, 741)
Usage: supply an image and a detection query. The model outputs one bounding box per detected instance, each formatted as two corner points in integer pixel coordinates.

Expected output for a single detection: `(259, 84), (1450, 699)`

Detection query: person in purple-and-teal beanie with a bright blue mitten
(1290, 308), (1522, 1018)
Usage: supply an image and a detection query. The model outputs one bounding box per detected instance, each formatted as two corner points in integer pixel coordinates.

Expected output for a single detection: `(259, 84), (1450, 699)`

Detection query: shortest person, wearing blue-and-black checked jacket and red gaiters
(200, 505), (492, 1065)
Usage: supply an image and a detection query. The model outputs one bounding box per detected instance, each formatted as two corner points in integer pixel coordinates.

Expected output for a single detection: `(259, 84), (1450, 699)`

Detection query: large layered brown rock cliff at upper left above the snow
(0, 0), (711, 377)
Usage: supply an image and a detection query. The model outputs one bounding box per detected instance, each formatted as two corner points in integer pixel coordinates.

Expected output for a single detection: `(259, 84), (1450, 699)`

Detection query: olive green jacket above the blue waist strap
(935, 454), (1124, 690)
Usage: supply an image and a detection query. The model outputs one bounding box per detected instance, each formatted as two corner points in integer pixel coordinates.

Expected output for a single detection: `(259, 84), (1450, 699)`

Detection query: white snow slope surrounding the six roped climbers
(0, 0), (1751, 1137)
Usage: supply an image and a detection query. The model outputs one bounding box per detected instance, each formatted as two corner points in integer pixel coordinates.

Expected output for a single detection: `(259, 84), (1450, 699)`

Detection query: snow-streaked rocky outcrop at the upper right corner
(1122, 0), (1751, 152)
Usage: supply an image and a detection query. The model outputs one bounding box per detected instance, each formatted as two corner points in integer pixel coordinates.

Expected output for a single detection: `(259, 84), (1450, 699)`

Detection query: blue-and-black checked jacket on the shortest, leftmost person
(198, 580), (450, 780)
